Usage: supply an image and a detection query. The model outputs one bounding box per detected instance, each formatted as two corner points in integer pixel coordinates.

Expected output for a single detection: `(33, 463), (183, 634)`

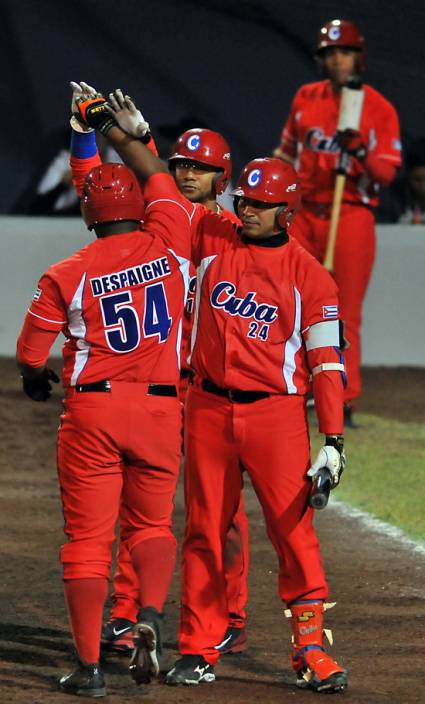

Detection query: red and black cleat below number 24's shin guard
(292, 648), (348, 694)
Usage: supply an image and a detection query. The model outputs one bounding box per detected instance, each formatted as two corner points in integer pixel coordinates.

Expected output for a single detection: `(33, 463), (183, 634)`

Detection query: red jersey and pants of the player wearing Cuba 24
(179, 213), (343, 664)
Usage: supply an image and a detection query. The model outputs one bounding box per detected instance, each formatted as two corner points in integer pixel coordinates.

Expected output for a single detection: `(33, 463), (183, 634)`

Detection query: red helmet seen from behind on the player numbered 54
(81, 164), (145, 230)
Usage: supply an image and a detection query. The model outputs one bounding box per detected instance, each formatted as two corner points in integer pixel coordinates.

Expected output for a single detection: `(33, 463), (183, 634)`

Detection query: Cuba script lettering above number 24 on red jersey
(211, 281), (278, 323)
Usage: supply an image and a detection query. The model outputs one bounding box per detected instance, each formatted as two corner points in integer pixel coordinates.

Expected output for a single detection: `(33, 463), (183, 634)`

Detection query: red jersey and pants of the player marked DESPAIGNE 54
(17, 174), (194, 662)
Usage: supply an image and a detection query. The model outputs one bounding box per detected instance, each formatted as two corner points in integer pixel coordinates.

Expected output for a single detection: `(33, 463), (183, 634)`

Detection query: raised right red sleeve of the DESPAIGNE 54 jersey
(143, 173), (195, 259)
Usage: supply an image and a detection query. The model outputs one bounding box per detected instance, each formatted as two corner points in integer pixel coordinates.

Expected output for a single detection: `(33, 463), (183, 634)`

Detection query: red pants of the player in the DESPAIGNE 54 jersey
(58, 382), (182, 580)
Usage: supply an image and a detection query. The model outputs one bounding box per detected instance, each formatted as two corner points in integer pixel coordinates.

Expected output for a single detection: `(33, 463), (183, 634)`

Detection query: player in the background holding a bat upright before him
(274, 19), (401, 426)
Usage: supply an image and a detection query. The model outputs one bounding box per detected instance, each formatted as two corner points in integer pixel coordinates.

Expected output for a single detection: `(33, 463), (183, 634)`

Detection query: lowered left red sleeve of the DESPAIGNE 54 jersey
(17, 272), (67, 367)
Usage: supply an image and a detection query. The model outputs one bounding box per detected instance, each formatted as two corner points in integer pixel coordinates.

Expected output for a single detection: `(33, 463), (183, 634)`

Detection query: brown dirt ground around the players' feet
(0, 360), (425, 704)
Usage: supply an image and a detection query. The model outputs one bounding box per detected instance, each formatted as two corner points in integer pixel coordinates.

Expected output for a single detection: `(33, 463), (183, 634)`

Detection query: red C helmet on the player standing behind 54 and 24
(168, 127), (232, 195)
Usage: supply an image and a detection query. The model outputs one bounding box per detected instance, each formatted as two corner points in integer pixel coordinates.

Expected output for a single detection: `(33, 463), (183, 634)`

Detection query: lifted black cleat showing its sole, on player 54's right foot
(129, 607), (161, 684)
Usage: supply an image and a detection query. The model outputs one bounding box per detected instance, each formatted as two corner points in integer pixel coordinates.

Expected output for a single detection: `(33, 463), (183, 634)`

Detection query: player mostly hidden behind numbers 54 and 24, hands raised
(71, 83), (249, 653)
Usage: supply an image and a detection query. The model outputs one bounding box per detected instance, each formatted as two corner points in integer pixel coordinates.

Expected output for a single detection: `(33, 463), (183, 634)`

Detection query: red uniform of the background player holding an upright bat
(279, 80), (401, 401)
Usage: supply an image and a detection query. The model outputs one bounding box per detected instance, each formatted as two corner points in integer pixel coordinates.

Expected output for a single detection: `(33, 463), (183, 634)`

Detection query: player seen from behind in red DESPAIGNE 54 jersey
(17, 113), (194, 697)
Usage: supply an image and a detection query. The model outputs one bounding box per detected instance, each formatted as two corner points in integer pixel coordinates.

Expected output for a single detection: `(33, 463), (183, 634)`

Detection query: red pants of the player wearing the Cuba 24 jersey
(179, 385), (328, 664)
